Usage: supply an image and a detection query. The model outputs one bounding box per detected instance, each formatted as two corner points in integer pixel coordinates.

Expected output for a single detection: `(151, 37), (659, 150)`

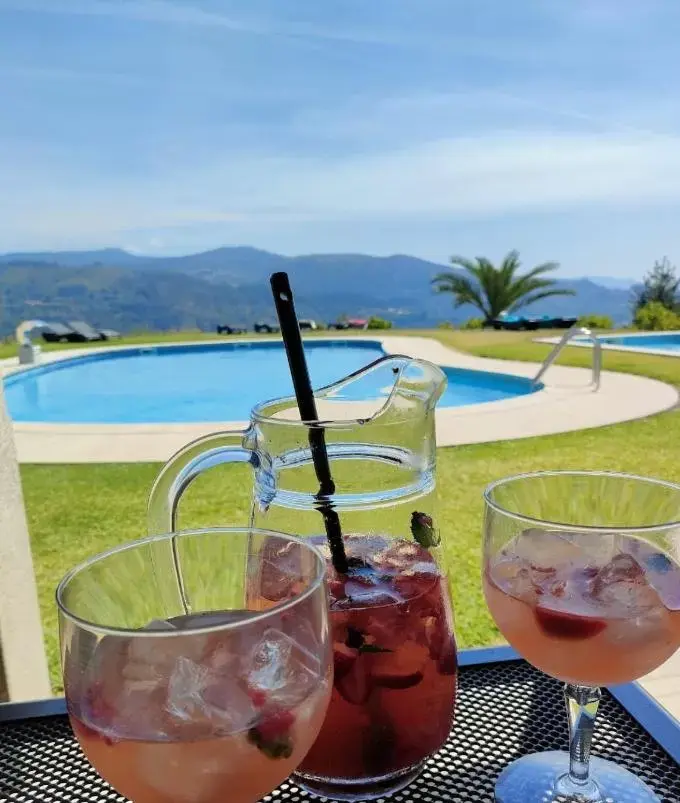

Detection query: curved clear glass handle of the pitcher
(147, 430), (258, 535)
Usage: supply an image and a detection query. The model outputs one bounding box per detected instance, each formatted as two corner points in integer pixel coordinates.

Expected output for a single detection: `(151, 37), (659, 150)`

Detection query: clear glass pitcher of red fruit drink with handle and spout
(149, 356), (457, 800)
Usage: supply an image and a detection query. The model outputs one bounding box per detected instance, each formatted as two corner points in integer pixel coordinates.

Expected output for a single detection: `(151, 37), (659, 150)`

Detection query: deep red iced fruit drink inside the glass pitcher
(299, 535), (456, 796)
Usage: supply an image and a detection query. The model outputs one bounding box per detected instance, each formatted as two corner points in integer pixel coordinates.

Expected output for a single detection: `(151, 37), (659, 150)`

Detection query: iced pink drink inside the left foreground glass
(66, 613), (330, 803)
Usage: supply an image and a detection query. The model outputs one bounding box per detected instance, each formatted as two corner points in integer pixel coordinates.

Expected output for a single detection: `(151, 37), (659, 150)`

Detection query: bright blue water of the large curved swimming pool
(5, 340), (532, 424)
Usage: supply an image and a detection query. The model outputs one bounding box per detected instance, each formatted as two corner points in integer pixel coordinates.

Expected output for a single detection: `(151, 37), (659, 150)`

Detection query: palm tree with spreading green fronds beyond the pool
(432, 251), (574, 323)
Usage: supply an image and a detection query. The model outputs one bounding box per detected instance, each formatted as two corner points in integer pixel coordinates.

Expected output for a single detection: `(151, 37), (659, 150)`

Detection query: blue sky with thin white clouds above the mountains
(0, 0), (680, 277)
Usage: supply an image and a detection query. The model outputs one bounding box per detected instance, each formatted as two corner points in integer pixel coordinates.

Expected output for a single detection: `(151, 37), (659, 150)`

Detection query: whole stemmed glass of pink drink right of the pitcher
(483, 471), (680, 803)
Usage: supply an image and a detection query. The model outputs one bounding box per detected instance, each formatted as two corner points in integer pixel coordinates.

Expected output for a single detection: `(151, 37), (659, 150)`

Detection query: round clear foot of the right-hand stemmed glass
(496, 750), (661, 803)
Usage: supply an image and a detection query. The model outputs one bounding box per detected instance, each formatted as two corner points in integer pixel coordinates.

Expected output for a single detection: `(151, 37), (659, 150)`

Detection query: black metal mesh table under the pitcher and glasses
(0, 647), (680, 803)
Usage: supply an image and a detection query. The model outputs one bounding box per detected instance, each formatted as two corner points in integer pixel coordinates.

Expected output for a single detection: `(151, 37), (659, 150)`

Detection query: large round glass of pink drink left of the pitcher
(57, 528), (332, 803)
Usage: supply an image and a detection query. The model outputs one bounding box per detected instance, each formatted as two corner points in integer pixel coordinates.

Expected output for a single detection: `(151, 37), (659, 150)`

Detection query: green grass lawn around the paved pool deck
(22, 331), (680, 690)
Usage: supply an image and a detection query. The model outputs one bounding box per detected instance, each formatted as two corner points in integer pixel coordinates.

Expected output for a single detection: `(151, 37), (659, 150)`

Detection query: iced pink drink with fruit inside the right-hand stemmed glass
(484, 530), (680, 686)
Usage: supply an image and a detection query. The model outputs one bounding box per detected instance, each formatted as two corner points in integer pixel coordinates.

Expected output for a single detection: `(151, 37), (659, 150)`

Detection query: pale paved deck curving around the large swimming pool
(0, 335), (679, 463)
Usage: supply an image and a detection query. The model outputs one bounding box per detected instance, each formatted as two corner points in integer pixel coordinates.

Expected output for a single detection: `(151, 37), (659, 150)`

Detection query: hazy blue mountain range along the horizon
(0, 247), (630, 335)
